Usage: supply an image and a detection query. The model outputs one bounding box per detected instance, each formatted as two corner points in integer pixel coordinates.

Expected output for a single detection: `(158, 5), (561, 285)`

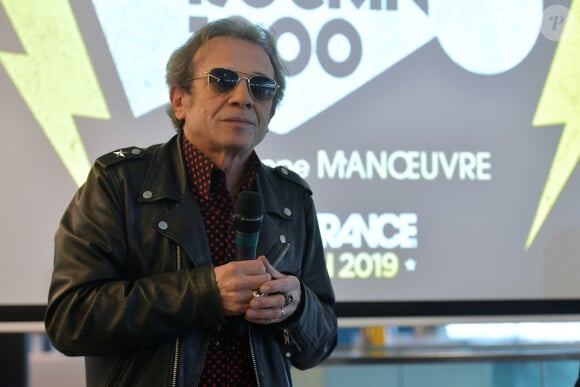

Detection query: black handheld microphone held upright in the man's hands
(232, 191), (264, 261)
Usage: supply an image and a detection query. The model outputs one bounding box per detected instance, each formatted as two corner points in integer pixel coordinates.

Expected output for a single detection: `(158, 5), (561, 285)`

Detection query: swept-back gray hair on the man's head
(166, 16), (286, 129)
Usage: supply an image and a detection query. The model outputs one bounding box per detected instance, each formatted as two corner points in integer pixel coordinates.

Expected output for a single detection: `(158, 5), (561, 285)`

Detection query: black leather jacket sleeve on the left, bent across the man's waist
(45, 161), (223, 356)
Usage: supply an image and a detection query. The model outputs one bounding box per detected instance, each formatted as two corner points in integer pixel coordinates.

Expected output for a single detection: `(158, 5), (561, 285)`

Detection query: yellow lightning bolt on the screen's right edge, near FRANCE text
(526, 1), (580, 249)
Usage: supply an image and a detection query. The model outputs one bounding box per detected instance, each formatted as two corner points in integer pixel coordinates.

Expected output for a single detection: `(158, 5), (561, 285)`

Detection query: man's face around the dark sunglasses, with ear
(171, 37), (274, 166)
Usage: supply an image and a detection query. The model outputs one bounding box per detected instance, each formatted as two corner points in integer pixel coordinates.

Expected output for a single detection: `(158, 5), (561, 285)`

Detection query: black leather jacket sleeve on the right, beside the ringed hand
(287, 195), (338, 369)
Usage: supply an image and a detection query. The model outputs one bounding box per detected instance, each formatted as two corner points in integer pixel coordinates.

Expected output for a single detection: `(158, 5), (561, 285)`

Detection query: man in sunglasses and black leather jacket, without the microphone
(45, 18), (337, 387)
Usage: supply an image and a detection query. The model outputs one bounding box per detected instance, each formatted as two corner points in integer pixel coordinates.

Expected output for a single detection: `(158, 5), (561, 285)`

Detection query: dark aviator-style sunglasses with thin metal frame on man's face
(192, 68), (280, 101)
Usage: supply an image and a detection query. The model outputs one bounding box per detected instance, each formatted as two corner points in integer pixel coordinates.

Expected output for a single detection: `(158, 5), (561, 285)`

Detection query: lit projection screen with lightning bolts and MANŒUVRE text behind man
(0, 0), (580, 321)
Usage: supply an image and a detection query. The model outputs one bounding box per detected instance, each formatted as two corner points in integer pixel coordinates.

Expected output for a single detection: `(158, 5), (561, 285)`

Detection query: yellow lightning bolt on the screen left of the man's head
(0, 0), (110, 185)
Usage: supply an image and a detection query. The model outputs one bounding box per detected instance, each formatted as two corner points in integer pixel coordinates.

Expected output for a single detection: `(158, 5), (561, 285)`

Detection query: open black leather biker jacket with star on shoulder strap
(45, 134), (337, 387)
